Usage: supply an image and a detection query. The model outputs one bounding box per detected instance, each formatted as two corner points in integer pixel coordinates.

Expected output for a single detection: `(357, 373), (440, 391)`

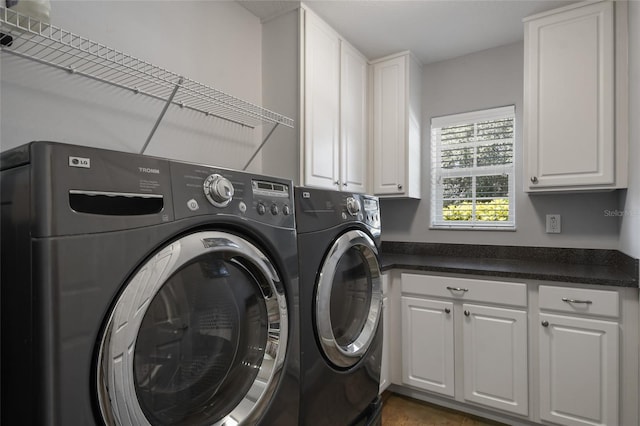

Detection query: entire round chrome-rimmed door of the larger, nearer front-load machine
(98, 232), (287, 425)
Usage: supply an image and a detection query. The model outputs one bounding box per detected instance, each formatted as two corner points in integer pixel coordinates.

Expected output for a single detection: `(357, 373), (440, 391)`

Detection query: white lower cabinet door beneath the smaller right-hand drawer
(539, 314), (616, 426)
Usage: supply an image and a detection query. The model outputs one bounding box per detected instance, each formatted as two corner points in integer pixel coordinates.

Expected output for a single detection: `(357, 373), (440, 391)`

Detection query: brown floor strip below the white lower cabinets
(382, 392), (502, 426)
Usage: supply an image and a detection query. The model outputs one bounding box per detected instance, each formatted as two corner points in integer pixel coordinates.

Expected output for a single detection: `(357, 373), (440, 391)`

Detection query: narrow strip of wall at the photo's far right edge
(620, 1), (640, 258)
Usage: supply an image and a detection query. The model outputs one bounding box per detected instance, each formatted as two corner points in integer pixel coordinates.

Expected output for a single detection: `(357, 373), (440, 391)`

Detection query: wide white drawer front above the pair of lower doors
(402, 274), (527, 306)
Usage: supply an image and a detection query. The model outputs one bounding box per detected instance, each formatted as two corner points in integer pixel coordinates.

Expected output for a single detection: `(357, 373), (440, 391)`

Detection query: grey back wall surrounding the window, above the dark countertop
(381, 43), (619, 249)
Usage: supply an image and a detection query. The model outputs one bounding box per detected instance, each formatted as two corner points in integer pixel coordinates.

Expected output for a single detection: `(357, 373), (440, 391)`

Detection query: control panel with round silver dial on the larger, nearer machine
(170, 162), (295, 228)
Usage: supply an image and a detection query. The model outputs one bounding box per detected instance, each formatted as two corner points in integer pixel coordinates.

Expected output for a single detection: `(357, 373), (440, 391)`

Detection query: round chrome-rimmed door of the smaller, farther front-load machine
(315, 230), (382, 368)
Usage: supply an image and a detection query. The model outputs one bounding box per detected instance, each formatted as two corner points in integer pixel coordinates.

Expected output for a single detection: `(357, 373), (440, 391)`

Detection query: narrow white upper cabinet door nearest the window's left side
(373, 56), (407, 195)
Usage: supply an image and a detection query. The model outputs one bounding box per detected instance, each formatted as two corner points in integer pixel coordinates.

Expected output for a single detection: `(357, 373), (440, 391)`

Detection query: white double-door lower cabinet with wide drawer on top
(402, 274), (529, 416)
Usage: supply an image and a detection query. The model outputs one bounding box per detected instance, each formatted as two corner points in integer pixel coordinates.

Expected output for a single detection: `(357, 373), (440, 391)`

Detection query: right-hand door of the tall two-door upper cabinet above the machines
(340, 41), (369, 193)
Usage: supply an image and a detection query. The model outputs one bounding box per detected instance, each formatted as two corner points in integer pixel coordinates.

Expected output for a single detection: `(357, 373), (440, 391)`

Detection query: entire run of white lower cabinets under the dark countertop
(388, 271), (640, 426)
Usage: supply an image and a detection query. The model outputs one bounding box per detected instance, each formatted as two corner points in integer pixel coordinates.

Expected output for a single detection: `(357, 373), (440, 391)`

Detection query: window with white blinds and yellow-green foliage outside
(431, 106), (515, 229)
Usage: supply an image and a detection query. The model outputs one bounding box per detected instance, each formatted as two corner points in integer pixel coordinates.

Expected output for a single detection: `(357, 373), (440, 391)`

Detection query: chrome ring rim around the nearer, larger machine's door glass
(97, 231), (288, 426)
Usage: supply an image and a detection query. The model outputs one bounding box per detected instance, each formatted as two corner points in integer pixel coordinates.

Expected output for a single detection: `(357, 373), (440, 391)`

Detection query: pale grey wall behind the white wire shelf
(0, 0), (263, 170)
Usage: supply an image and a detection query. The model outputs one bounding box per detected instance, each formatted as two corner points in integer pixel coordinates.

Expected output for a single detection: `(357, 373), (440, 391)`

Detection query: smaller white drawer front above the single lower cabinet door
(539, 285), (620, 318)
